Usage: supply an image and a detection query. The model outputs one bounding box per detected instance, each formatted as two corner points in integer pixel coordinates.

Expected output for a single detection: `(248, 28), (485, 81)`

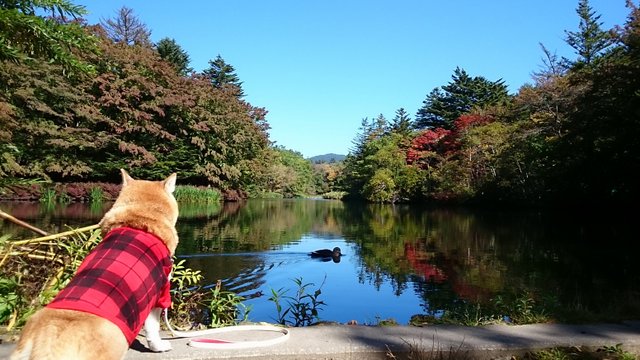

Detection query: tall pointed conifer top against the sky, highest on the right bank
(565, 0), (613, 65)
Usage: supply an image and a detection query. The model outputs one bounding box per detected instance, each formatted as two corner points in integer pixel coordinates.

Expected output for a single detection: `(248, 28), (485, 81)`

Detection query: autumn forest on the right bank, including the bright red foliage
(341, 0), (640, 205)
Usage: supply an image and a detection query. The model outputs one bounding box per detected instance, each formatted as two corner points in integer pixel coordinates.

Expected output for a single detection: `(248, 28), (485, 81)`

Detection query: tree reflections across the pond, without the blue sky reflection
(0, 200), (640, 315)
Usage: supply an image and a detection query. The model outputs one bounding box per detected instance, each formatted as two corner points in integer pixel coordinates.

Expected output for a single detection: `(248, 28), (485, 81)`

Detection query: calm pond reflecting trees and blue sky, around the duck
(0, 199), (640, 324)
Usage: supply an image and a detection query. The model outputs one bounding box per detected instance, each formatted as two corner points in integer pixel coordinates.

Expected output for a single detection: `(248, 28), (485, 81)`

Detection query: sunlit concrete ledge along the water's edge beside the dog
(0, 322), (640, 360)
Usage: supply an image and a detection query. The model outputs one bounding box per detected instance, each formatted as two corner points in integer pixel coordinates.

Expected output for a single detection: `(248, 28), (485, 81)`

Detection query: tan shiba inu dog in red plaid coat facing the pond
(10, 170), (178, 360)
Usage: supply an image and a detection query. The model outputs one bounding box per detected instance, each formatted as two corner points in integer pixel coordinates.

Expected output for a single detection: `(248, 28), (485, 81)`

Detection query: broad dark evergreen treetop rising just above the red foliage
(414, 67), (509, 129)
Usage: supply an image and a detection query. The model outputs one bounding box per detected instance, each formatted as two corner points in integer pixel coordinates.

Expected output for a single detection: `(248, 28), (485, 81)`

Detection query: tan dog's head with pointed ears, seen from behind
(100, 169), (178, 255)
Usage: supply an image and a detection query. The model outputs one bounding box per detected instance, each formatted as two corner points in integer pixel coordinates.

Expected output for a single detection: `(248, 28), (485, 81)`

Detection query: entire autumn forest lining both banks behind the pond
(0, 0), (640, 205)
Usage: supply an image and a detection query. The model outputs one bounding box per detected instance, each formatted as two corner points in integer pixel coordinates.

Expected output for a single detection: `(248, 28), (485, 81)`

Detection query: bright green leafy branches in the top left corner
(0, 0), (96, 74)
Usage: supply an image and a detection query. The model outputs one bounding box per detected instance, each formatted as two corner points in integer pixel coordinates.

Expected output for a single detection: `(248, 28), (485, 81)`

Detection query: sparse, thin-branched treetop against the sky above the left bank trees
(101, 6), (151, 46)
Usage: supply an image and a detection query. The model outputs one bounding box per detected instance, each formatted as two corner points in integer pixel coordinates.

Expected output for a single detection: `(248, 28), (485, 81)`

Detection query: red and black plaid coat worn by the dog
(47, 227), (171, 344)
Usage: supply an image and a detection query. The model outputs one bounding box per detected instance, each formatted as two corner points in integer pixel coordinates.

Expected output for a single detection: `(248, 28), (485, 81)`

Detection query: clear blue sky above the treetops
(77, 0), (628, 157)
